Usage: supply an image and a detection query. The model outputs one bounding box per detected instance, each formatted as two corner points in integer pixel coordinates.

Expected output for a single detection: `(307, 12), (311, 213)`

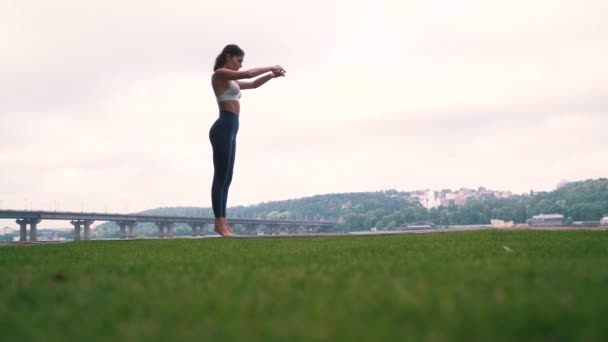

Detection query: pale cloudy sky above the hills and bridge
(0, 0), (608, 225)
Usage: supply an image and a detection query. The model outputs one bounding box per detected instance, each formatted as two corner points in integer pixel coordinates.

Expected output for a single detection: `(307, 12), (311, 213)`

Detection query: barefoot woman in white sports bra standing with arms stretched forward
(209, 44), (285, 237)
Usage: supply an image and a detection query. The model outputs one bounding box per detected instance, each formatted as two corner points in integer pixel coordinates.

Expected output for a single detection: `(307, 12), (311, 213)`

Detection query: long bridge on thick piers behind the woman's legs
(0, 210), (335, 242)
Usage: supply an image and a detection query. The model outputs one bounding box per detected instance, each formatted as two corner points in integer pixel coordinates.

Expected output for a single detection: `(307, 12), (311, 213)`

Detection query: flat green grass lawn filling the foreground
(0, 230), (608, 342)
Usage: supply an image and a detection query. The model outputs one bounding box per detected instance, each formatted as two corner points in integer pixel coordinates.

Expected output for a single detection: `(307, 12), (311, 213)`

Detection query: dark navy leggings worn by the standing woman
(209, 111), (239, 217)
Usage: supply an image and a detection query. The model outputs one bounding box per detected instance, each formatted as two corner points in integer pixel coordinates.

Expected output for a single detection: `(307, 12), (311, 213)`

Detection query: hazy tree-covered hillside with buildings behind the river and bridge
(99, 178), (608, 235)
